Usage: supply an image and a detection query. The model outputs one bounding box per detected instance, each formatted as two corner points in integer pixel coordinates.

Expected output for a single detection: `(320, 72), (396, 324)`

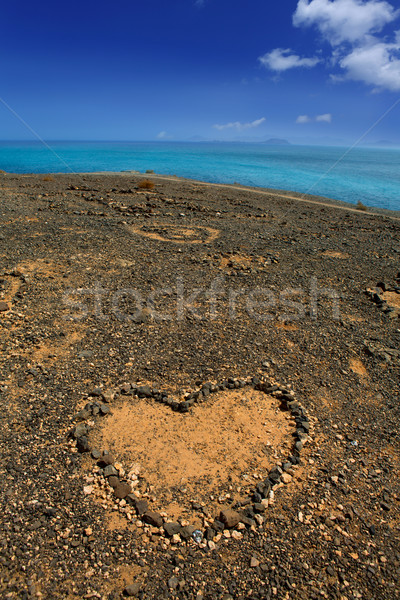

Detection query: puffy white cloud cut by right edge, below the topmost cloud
(339, 32), (400, 91)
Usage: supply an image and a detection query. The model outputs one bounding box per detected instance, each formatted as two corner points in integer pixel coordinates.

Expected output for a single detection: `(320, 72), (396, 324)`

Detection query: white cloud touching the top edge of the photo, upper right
(293, 0), (400, 45)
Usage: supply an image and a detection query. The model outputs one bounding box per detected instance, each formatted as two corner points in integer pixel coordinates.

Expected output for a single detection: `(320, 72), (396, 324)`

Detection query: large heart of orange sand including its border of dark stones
(72, 378), (309, 535)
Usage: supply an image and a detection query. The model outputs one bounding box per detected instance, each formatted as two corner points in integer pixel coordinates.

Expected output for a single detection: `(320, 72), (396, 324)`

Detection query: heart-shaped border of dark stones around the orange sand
(69, 376), (310, 543)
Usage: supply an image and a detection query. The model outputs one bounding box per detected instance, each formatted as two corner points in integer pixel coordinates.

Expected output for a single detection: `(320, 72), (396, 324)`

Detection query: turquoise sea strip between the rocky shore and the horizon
(0, 142), (400, 210)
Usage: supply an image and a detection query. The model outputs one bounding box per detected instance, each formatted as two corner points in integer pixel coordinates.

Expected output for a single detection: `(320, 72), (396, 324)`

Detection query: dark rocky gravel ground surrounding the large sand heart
(0, 173), (400, 600)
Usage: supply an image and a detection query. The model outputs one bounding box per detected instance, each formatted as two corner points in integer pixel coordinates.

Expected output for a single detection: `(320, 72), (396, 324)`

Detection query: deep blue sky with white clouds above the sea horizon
(0, 0), (400, 143)
